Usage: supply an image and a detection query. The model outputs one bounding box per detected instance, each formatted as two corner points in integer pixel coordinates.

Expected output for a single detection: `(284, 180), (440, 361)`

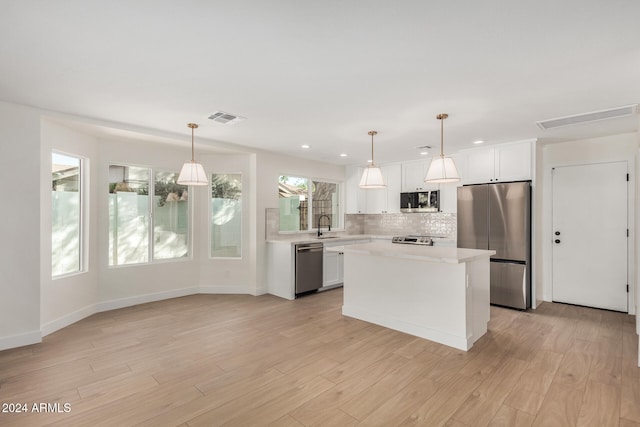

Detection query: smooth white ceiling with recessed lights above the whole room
(0, 0), (640, 164)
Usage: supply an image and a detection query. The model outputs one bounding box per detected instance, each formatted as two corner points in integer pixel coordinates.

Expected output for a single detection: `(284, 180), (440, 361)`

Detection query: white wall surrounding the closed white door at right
(538, 133), (638, 314)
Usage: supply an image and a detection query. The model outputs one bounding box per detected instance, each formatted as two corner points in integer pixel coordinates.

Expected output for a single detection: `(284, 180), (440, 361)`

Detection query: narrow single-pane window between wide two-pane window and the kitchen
(211, 174), (242, 258)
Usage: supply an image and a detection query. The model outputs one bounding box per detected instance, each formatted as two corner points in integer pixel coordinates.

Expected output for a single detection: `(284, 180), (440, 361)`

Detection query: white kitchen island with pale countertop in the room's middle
(327, 242), (495, 351)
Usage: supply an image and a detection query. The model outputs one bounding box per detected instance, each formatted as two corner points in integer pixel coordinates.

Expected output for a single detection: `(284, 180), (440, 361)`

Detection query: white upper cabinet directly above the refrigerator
(462, 141), (533, 184)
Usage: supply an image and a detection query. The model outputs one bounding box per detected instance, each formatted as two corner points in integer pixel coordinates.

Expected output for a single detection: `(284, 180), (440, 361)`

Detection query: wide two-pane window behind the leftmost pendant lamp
(109, 165), (189, 266)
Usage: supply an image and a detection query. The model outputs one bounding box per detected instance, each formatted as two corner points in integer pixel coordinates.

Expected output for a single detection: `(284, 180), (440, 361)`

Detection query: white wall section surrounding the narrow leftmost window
(40, 118), (100, 336)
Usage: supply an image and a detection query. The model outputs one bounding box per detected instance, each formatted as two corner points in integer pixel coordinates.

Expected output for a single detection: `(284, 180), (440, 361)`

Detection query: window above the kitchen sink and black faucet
(278, 175), (341, 231)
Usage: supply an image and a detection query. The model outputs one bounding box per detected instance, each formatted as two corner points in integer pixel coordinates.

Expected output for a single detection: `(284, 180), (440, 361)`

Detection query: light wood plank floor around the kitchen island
(0, 289), (640, 427)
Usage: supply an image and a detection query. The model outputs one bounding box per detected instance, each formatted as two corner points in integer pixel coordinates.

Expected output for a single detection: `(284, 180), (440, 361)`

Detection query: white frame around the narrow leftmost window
(49, 149), (89, 280)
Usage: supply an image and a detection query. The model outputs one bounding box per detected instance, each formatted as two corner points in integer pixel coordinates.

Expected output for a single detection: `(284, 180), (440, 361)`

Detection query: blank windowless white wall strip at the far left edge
(0, 102), (41, 350)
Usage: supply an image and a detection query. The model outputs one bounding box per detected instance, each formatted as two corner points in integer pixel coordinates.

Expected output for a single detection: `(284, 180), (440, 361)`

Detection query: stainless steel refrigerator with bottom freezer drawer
(457, 181), (531, 310)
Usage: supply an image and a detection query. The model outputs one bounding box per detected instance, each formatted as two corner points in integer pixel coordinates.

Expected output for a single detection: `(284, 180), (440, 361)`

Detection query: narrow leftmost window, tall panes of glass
(51, 153), (83, 277)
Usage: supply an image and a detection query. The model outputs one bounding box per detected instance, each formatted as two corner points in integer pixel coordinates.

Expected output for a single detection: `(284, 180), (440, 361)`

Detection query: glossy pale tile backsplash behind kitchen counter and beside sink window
(265, 208), (457, 240)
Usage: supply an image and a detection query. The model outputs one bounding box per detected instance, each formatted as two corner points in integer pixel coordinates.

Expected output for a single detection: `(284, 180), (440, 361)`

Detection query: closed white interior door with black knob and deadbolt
(551, 162), (628, 312)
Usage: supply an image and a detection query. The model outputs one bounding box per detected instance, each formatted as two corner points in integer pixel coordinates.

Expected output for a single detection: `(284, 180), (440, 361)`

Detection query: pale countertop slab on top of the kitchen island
(326, 239), (496, 264)
